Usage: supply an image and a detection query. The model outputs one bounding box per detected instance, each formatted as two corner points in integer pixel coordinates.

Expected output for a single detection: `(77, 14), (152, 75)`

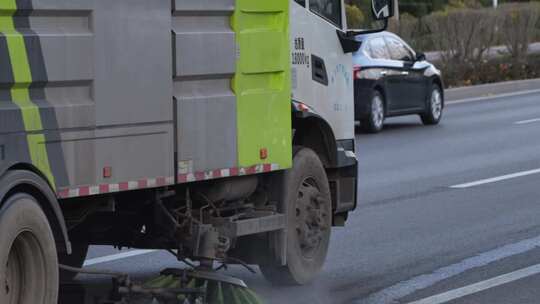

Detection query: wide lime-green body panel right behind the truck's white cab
(233, 0), (292, 168)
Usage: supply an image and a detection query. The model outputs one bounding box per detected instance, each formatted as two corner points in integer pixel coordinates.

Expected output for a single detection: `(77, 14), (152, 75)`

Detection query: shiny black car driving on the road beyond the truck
(353, 32), (444, 133)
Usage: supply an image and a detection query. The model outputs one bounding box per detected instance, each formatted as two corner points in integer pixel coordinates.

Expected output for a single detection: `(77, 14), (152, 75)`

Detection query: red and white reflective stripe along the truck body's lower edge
(58, 164), (279, 198)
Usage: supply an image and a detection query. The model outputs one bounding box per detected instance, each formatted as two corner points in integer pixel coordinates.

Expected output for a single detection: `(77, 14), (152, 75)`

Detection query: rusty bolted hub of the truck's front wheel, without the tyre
(296, 178), (329, 258)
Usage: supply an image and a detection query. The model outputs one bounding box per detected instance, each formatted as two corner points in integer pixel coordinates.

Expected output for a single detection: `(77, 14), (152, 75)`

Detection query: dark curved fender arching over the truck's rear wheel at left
(0, 169), (71, 254)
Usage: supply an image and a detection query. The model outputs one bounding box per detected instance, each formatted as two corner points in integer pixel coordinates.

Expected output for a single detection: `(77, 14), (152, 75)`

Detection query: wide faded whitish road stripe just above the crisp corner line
(355, 236), (540, 304)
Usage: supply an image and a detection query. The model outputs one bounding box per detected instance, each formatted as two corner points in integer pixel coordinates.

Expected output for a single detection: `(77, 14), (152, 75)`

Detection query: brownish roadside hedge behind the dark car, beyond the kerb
(390, 0), (540, 86)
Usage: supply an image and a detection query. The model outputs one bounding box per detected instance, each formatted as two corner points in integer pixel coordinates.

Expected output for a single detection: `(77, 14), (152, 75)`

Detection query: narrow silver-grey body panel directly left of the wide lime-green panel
(172, 0), (238, 173)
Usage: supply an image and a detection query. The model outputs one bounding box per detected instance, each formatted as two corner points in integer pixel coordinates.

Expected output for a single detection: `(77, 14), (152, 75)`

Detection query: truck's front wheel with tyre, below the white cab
(261, 148), (332, 285)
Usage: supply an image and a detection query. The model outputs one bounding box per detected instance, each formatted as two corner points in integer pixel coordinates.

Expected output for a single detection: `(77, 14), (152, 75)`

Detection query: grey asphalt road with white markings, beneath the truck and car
(62, 93), (540, 304)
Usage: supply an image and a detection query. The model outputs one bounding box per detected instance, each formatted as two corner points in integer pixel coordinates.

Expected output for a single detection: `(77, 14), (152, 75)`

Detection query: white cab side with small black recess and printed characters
(291, 0), (354, 140)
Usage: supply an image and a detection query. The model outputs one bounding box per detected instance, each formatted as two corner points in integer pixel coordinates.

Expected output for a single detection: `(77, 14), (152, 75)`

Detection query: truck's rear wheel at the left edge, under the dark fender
(0, 193), (58, 304)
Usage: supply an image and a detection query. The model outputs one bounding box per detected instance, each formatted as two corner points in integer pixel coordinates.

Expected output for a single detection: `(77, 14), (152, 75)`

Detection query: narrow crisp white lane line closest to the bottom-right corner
(409, 264), (540, 304)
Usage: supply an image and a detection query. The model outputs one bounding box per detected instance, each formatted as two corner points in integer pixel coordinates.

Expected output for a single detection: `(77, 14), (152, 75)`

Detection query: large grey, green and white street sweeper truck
(0, 0), (391, 304)
